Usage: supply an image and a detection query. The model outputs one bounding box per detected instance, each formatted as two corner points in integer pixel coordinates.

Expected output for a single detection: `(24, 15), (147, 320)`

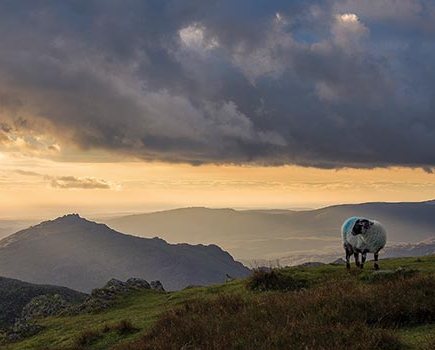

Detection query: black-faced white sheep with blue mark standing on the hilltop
(341, 216), (387, 270)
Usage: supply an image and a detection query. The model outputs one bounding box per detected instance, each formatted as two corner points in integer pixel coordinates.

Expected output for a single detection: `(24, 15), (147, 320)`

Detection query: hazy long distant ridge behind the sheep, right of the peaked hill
(103, 201), (435, 261)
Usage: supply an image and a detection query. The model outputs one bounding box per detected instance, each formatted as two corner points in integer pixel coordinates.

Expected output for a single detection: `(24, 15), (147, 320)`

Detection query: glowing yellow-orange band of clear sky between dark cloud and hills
(0, 153), (435, 219)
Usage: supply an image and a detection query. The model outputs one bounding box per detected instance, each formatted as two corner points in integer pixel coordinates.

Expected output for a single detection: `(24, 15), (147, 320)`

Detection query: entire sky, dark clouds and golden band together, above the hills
(0, 0), (435, 218)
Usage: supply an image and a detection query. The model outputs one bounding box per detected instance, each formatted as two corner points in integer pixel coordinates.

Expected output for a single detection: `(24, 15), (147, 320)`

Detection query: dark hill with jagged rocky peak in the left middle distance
(0, 214), (249, 292)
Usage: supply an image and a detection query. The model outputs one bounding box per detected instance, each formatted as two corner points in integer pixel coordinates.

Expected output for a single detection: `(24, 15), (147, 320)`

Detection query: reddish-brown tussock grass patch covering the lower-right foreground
(116, 276), (435, 350)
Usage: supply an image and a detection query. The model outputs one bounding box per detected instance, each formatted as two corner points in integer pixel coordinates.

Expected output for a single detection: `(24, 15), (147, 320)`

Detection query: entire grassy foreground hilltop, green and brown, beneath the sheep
(3, 256), (435, 350)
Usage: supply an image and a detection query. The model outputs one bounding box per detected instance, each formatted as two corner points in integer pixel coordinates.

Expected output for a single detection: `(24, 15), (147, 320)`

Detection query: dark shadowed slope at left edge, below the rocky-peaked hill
(0, 277), (86, 330)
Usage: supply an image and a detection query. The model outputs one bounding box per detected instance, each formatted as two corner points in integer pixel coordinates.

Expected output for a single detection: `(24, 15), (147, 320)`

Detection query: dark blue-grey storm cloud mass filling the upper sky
(0, 0), (435, 169)
